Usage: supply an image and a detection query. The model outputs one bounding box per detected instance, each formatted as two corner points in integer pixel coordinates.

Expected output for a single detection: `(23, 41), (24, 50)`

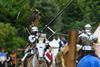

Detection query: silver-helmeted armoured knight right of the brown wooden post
(77, 24), (93, 61)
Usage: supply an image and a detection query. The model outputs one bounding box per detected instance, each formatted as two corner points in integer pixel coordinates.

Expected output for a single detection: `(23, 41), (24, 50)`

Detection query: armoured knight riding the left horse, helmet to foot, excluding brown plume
(22, 23), (39, 61)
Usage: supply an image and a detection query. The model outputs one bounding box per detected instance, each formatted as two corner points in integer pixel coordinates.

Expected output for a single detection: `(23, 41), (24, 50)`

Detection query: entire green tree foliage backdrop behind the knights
(0, 0), (100, 50)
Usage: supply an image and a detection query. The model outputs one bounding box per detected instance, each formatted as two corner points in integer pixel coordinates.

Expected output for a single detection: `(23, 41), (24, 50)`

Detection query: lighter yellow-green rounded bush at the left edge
(0, 23), (26, 51)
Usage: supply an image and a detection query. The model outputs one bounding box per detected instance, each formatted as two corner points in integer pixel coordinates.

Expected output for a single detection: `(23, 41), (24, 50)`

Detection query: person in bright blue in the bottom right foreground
(77, 39), (100, 67)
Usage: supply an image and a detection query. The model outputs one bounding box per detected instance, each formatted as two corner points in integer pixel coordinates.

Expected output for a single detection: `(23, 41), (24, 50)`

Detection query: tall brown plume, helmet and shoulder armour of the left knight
(28, 9), (40, 44)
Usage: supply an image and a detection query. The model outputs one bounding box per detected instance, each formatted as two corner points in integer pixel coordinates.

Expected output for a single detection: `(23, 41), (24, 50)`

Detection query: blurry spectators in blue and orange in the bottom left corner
(0, 49), (16, 67)
